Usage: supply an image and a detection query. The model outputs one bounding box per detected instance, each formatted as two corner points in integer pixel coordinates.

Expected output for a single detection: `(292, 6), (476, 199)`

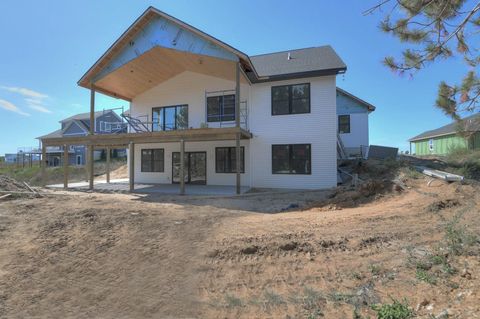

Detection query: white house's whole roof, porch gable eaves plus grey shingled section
(78, 7), (346, 100)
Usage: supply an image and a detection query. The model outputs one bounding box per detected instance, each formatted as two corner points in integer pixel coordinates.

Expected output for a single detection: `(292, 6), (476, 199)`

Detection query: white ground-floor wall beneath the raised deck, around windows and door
(134, 140), (250, 186)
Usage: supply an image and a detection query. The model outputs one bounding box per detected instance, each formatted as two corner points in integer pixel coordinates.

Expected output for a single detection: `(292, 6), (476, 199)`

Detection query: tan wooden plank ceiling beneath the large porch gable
(95, 47), (247, 100)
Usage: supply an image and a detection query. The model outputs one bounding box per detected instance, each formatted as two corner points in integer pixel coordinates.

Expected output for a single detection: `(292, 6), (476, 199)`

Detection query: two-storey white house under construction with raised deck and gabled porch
(42, 7), (372, 193)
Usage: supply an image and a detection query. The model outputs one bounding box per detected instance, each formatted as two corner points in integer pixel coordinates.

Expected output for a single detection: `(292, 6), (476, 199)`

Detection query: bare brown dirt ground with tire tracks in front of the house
(0, 170), (480, 319)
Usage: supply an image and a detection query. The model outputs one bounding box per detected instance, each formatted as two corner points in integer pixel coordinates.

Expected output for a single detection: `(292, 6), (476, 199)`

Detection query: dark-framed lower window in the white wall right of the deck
(272, 144), (312, 174)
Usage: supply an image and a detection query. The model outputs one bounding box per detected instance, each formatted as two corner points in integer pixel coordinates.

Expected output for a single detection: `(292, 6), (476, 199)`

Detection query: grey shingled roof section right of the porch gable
(247, 45), (347, 82)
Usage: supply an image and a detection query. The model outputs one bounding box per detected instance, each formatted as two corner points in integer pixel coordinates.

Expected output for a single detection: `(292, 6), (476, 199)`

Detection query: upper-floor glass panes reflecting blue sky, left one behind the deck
(152, 105), (188, 131)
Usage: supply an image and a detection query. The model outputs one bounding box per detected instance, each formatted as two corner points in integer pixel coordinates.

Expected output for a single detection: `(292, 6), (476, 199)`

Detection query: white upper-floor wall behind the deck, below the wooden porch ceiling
(130, 67), (251, 128)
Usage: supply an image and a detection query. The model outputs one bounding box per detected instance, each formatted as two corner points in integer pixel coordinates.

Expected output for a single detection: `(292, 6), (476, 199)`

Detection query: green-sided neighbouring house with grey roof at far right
(409, 113), (480, 155)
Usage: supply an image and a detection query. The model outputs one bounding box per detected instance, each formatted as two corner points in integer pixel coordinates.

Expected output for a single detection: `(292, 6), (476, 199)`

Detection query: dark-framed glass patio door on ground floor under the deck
(172, 152), (207, 185)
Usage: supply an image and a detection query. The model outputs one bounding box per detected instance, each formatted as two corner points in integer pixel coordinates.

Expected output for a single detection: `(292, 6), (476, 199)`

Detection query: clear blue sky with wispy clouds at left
(0, 0), (467, 154)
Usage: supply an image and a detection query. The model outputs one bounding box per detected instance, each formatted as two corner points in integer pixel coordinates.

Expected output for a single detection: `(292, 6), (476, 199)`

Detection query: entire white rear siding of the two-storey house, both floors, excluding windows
(130, 70), (337, 189)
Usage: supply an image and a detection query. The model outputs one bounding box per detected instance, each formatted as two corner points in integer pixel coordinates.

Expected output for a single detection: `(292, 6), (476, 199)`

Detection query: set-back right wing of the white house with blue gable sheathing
(337, 87), (375, 156)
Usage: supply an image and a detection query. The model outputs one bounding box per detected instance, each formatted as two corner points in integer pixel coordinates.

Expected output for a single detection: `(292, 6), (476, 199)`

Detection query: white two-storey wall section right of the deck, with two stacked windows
(249, 76), (337, 189)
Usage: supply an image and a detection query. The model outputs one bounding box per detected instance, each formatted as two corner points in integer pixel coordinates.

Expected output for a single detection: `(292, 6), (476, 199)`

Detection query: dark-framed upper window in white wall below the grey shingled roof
(272, 83), (310, 115)
